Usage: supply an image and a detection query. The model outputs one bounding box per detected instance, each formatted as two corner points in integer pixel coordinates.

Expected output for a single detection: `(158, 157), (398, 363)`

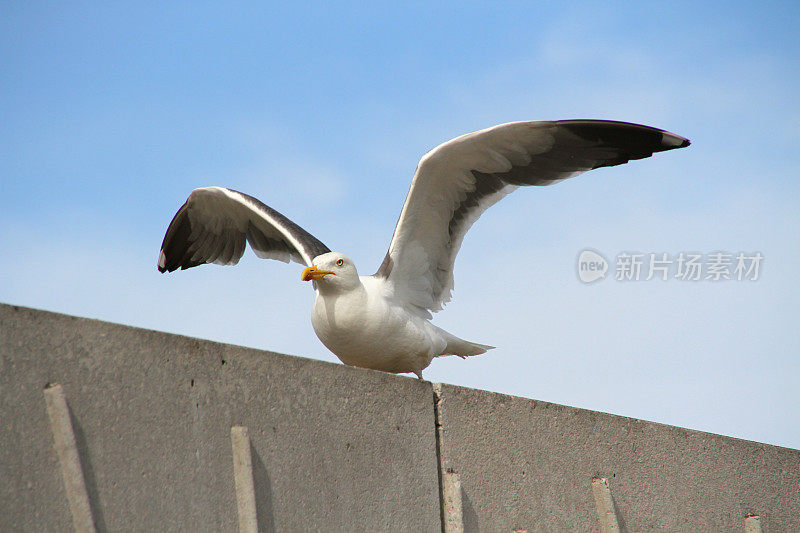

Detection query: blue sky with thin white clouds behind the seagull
(0, 2), (800, 448)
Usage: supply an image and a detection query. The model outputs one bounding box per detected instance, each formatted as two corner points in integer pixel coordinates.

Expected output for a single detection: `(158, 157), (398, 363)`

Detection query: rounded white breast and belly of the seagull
(311, 278), (446, 372)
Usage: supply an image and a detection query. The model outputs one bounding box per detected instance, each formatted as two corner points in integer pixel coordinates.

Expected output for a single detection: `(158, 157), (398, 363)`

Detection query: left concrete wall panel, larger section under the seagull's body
(0, 305), (441, 531)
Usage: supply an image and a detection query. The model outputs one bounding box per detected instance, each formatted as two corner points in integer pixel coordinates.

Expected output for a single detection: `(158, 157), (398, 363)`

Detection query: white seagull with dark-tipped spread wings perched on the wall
(158, 120), (689, 379)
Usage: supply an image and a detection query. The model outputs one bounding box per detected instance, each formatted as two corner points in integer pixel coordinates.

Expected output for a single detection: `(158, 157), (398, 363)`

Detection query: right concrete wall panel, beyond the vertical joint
(437, 385), (800, 532)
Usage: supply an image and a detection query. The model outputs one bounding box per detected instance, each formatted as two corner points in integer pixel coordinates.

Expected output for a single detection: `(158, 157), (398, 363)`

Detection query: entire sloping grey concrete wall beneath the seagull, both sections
(0, 304), (800, 531)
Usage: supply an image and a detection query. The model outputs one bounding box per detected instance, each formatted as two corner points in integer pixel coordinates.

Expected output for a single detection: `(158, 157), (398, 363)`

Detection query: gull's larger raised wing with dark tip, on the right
(375, 120), (689, 317)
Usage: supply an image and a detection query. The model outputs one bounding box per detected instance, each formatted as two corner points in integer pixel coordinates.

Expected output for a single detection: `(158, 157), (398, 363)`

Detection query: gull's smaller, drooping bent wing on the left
(158, 187), (330, 272)
